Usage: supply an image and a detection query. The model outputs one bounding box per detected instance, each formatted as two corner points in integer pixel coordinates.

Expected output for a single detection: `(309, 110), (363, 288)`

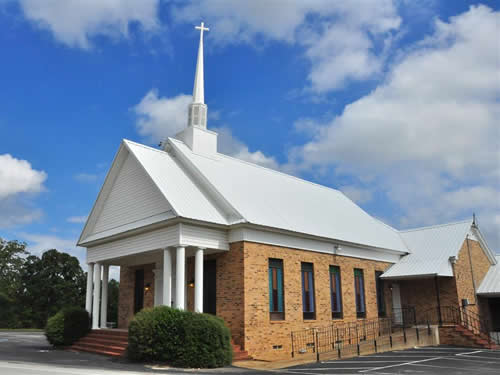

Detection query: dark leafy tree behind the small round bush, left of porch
(19, 249), (86, 328)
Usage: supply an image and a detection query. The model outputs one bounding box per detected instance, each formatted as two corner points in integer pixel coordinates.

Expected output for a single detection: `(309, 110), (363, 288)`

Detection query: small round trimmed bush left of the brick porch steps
(45, 307), (90, 346)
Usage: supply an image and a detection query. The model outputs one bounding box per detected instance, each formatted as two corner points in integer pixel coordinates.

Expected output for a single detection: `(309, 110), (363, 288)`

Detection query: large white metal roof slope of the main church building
(169, 139), (408, 253)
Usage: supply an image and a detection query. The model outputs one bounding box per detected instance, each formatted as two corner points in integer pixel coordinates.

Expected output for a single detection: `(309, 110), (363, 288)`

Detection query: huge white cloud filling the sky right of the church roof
(289, 6), (500, 249)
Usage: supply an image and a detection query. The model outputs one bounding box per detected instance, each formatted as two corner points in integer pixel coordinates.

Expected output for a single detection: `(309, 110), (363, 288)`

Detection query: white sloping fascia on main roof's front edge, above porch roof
(167, 138), (243, 222)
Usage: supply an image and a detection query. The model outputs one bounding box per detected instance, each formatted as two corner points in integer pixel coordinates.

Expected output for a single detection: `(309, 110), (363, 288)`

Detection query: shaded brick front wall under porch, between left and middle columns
(118, 264), (155, 328)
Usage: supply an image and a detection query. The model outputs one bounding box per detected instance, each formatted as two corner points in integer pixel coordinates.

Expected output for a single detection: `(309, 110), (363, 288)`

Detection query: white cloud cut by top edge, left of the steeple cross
(18, 0), (159, 49)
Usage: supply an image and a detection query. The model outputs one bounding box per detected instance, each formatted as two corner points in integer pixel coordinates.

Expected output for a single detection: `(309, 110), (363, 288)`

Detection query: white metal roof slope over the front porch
(123, 140), (228, 224)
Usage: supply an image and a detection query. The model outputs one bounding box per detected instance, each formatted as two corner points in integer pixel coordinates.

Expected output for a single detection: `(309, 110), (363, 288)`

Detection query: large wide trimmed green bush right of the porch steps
(127, 306), (233, 368)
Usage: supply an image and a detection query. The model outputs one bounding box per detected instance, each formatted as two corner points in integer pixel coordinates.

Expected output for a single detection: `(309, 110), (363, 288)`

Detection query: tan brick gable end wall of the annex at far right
(454, 240), (491, 313)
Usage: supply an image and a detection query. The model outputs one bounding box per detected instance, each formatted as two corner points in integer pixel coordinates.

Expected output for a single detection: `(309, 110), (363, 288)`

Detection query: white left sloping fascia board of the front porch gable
(77, 140), (130, 246)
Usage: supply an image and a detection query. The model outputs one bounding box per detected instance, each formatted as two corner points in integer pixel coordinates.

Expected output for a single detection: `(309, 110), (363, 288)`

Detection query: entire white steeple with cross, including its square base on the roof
(173, 22), (217, 155)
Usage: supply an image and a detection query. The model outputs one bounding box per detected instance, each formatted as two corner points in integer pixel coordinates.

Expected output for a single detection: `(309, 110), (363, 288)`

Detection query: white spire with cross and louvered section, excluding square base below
(188, 22), (209, 129)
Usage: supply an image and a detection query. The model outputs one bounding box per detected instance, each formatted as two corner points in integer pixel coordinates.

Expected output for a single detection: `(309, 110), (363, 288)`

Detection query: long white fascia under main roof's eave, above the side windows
(229, 226), (406, 263)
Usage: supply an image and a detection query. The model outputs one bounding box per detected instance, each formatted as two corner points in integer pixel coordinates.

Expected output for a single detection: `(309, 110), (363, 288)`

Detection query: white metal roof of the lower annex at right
(383, 220), (472, 278)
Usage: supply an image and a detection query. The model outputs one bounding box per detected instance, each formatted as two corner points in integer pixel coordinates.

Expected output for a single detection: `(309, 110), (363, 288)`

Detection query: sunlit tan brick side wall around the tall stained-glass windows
(242, 242), (390, 358)
